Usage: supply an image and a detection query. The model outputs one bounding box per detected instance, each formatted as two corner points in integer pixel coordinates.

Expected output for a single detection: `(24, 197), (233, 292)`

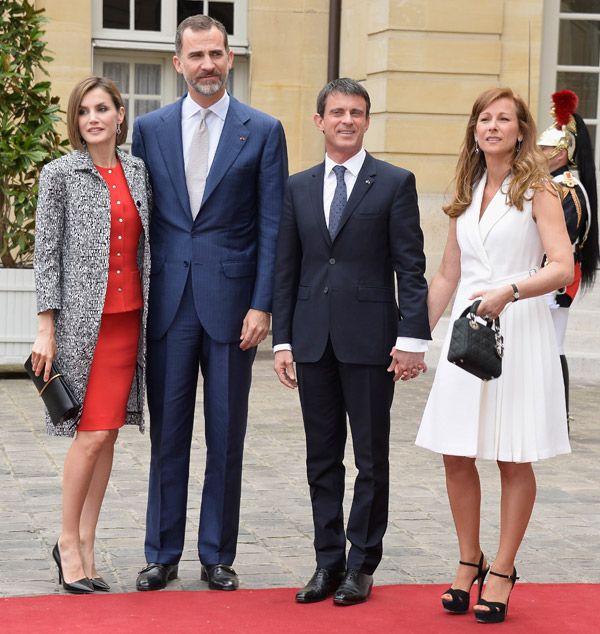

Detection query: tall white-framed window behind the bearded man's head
(92, 0), (249, 140)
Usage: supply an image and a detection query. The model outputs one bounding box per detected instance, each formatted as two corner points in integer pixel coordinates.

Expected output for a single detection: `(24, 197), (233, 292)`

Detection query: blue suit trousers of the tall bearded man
(145, 274), (256, 565)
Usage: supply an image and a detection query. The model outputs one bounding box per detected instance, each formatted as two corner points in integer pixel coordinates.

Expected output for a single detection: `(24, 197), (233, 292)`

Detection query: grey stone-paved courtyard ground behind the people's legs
(0, 351), (600, 596)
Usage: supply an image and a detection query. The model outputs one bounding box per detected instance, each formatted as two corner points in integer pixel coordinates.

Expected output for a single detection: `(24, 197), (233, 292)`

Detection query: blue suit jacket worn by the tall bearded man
(132, 97), (287, 343)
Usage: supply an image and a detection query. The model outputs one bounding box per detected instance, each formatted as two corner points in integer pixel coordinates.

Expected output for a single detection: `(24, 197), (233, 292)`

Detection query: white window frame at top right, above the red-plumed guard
(538, 0), (600, 175)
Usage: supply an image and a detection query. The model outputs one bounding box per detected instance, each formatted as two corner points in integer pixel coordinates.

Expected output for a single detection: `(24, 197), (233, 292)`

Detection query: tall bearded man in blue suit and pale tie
(132, 15), (287, 590)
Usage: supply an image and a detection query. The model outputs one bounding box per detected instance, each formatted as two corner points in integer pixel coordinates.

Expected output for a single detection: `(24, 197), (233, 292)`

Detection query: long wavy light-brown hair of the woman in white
(443, 88), (552, 218)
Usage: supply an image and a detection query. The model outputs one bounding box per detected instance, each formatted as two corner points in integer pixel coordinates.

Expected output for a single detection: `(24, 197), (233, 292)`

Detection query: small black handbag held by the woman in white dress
(448, 300), (504, 381)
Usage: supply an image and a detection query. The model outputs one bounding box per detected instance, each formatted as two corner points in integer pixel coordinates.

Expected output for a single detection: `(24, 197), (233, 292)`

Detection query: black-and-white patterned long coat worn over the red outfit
(34, 148), (152, 436)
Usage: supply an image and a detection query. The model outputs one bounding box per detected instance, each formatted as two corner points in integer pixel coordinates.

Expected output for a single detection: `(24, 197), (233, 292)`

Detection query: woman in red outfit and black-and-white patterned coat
(32, 77), (150, 594)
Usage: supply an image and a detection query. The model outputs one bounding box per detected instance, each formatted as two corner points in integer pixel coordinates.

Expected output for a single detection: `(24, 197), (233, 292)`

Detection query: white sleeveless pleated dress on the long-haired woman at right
(416, 175), (571, 462)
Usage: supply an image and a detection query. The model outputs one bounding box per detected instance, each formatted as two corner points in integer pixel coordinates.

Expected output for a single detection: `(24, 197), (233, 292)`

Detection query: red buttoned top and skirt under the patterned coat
(78, 163), (143, 431)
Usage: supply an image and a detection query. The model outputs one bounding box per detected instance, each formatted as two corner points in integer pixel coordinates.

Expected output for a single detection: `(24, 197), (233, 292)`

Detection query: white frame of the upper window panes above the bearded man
(92, 0), (248, 55)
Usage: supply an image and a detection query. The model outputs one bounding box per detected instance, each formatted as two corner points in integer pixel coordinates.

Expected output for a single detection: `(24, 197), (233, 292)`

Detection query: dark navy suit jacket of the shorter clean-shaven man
(273, 154), (431, 365)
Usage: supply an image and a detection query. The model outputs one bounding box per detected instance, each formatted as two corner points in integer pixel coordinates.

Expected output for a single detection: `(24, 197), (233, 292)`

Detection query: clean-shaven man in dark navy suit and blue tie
(273, 79), (431, 605)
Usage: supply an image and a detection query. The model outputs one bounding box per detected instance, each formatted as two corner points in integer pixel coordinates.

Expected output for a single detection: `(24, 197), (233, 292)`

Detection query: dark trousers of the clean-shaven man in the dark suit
(296, 341), (394, 574)
